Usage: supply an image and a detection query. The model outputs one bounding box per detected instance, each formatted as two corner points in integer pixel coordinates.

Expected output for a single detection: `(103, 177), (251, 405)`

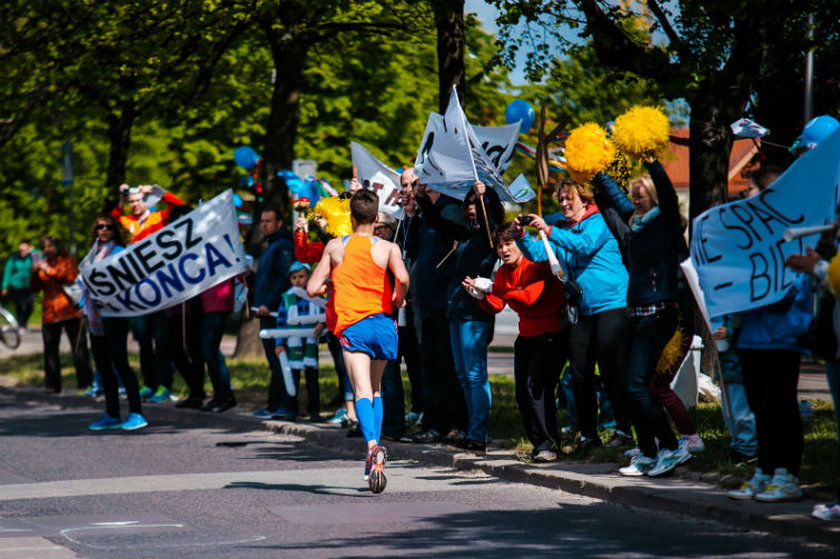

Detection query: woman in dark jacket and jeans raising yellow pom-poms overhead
(594, 161), (691, 476)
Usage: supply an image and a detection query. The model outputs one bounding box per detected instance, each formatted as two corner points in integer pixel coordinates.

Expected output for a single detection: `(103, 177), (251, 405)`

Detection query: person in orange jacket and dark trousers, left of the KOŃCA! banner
(29, 236), (93, 394)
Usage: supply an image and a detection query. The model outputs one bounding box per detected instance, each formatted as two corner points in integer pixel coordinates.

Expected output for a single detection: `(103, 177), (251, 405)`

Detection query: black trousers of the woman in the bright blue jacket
(569, 308), (630, 439)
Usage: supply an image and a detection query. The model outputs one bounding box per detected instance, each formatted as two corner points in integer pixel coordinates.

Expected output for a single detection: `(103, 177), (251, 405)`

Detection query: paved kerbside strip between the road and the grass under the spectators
(0, 383), (840, 557)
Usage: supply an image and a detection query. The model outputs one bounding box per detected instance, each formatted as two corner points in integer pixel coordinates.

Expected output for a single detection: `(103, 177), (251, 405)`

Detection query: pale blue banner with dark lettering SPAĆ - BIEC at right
(691, 131), (840, 318)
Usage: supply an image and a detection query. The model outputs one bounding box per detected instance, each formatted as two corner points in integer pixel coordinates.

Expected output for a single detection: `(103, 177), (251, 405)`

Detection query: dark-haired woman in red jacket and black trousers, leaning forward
(462, 222), (568, 462)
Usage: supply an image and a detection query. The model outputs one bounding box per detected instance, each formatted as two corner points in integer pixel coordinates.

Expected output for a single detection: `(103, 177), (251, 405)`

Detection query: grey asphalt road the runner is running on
(0, 393), (825, 559)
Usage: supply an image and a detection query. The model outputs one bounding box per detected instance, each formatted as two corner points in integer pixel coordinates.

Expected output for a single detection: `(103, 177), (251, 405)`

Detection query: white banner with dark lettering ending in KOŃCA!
(79, 190), (247, 316)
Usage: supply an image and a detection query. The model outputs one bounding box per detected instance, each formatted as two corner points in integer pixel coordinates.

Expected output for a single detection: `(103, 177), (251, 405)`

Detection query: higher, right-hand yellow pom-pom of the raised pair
(612, 105), (671, 159)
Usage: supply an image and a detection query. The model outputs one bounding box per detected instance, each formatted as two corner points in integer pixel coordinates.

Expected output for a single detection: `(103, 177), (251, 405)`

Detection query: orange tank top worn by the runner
(332, 235), (393, 336)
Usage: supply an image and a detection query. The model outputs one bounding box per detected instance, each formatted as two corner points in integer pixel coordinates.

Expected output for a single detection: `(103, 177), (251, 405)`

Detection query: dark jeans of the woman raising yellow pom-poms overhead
(627, 309), (678, 458)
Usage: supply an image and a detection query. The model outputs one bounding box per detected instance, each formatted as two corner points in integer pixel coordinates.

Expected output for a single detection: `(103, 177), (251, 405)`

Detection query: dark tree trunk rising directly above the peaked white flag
(431, 0), (467, 114)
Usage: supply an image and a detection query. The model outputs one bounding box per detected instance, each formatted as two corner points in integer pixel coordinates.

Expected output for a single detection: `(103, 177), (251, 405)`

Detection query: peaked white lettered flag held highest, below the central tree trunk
(415, 87), (536, 203)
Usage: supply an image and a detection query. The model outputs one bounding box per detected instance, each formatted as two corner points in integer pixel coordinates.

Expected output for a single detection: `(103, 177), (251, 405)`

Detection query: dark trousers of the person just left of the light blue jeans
(420, 314), (467, 435)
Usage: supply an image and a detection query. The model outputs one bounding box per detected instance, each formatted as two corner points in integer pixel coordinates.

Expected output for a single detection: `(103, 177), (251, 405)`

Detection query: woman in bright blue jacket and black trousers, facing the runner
(517, 180), (632, 454)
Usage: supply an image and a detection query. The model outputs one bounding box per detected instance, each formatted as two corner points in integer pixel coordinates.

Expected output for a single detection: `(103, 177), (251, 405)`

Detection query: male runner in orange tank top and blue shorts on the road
(307, 190), (408, 493)
